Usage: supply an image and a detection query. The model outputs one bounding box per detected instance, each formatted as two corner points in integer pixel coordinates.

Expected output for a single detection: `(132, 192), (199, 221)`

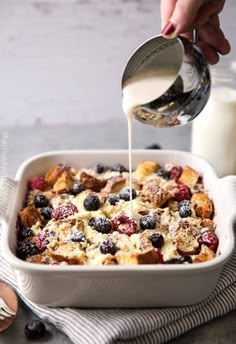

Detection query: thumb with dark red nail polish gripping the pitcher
(162, 0), (204, 36)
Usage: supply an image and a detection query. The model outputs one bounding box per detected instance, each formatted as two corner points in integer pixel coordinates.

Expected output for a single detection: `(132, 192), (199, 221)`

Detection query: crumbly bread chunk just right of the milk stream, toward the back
(140, 179), (171, 207)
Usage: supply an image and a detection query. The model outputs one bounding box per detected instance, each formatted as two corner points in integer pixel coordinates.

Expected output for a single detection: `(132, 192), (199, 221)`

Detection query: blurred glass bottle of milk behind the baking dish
(191, 60), (236, 177)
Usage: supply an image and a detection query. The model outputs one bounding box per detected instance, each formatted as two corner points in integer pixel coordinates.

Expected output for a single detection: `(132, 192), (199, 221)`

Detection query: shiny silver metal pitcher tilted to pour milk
(122, 31), (211, 127)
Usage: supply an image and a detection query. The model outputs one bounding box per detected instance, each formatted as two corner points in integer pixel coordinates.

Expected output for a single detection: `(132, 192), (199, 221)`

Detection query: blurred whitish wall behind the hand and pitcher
(0, 0), (236, 126)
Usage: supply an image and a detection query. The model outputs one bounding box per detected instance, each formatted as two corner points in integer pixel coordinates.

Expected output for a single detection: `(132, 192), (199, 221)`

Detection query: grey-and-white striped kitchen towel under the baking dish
(0, 238), (236, 344)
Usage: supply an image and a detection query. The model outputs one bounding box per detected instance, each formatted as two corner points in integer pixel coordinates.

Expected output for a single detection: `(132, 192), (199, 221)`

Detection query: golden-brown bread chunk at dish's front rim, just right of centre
(115, 249), (161, 265)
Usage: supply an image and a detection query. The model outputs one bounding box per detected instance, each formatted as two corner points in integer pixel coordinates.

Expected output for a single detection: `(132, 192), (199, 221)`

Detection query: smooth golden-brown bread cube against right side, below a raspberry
(191, 192), (213, 219)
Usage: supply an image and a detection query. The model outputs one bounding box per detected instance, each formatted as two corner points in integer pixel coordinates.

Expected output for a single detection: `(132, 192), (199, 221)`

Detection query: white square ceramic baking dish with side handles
(0, 150), (236, 308)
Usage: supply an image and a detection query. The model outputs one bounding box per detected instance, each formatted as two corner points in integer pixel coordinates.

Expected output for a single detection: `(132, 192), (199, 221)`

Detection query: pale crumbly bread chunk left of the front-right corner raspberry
(174, 227), (199, 254)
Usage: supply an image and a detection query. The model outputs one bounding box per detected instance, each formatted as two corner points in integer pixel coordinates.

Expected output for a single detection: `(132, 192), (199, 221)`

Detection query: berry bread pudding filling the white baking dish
(16, 161), (218, 265)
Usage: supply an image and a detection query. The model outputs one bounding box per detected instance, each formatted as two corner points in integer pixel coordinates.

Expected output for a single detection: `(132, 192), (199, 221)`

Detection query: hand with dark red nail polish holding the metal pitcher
(161, 0), (230, 64)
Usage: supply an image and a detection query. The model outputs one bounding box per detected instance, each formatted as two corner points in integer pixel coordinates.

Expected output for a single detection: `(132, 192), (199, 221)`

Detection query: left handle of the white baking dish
(0, 177), (17, 221)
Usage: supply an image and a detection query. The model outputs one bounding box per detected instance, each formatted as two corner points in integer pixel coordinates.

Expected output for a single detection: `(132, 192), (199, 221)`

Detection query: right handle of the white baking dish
(219, 175), (236, 228)
